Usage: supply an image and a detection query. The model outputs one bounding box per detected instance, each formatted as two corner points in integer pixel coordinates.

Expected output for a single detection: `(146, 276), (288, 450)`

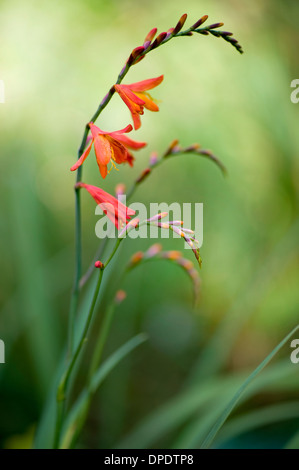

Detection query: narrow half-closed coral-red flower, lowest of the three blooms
(76, 183), (135, 230)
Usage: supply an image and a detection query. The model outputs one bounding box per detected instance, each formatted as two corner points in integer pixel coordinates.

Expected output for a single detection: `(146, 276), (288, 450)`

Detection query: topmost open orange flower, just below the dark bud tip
(114, 75), (164, 130)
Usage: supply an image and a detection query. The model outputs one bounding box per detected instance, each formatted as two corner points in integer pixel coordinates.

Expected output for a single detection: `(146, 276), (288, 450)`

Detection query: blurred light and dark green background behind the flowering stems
(0, 0), (299, 448)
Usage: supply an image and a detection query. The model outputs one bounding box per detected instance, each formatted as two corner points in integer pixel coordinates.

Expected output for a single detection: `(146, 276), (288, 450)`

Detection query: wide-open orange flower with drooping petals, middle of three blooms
(71, 122), (146, 178)
